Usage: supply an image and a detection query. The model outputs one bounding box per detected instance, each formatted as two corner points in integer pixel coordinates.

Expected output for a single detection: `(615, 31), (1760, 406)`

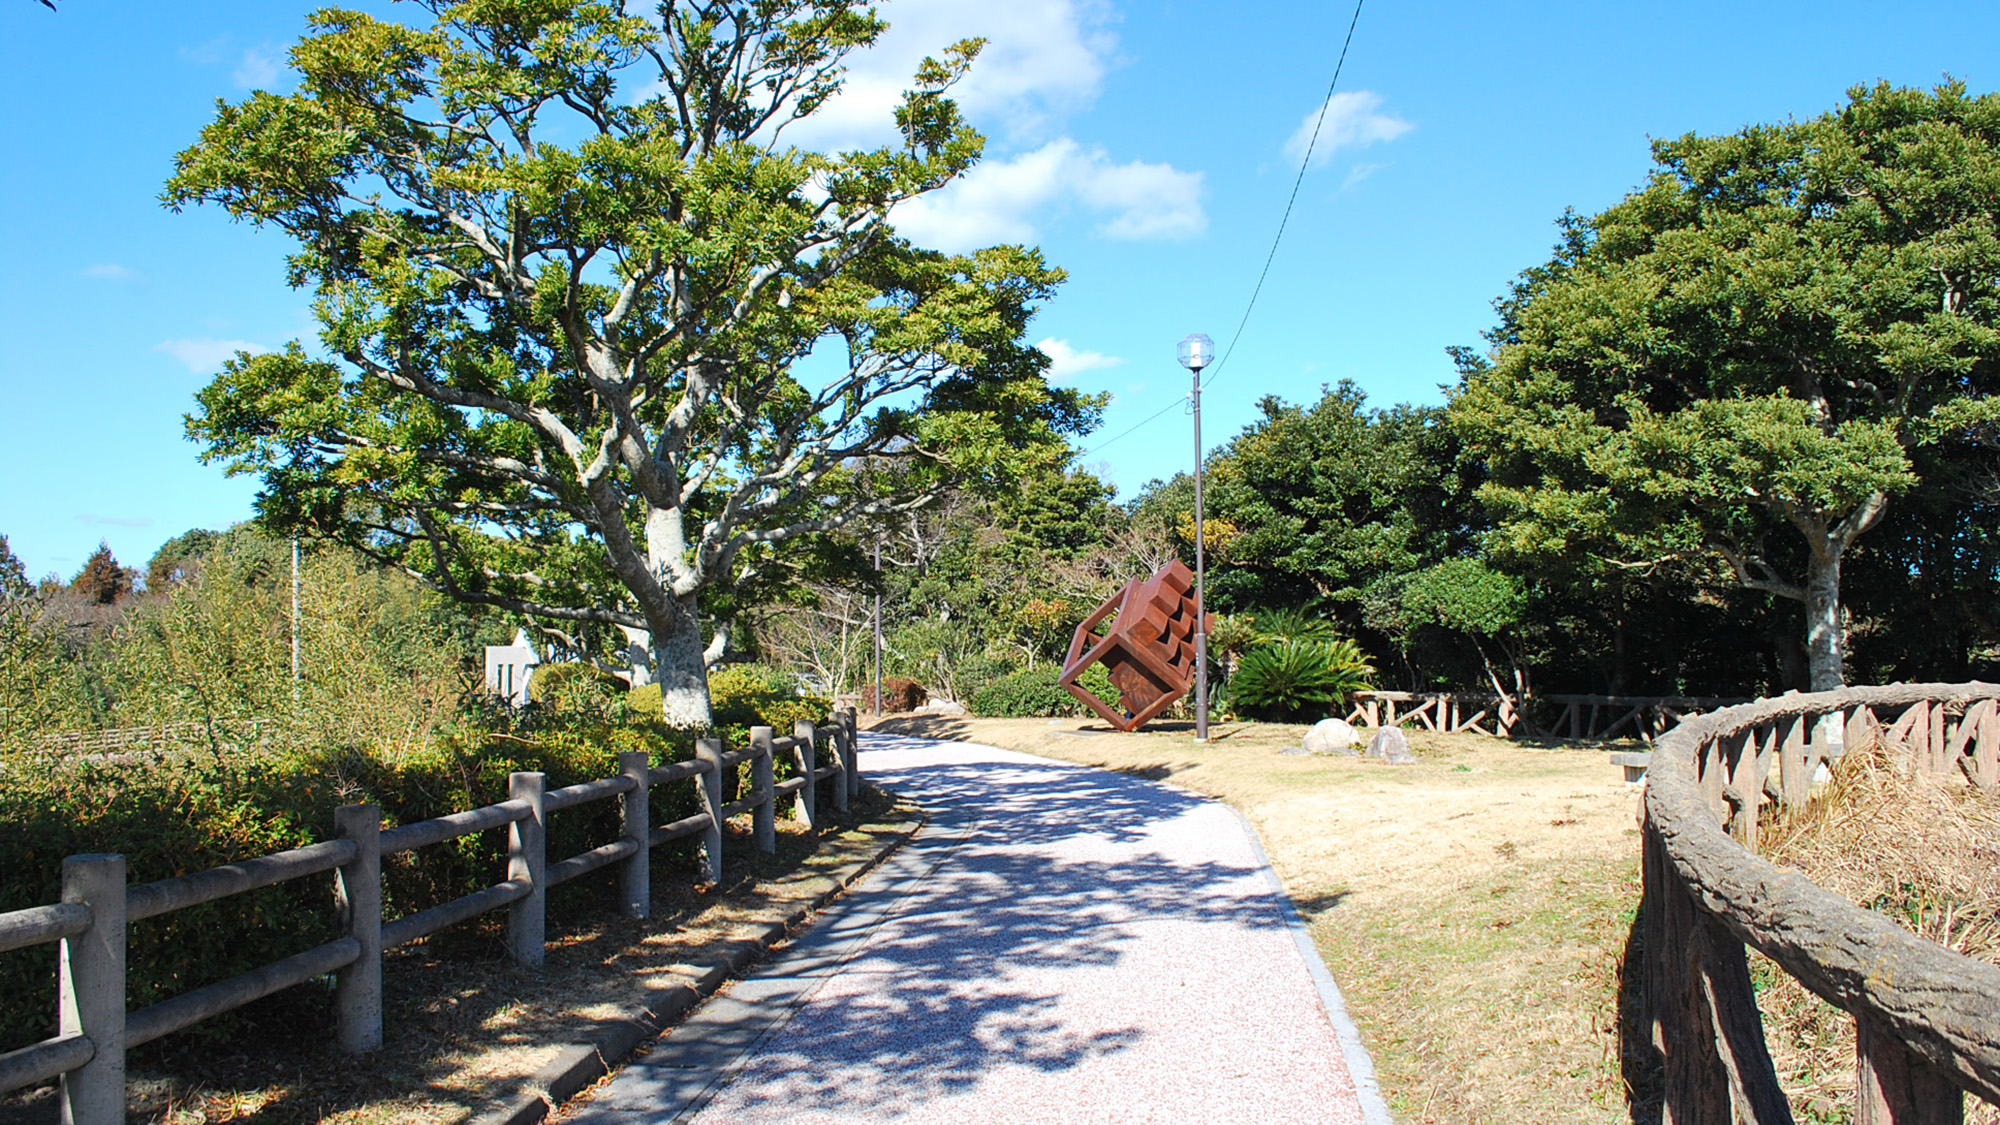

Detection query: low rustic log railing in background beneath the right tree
(1348, 691), (1744, 743)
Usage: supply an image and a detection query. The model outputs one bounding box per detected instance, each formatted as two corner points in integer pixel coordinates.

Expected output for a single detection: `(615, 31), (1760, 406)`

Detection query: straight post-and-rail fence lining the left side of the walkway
(0, 711), (860, 1125)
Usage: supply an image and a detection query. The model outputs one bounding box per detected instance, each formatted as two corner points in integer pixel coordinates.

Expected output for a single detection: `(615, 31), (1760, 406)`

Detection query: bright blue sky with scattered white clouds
(0, 0), (2000, 575)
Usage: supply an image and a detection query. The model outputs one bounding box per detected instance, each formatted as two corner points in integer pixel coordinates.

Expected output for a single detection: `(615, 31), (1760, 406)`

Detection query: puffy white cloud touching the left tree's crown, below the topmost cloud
(894, 136), (1208, 250)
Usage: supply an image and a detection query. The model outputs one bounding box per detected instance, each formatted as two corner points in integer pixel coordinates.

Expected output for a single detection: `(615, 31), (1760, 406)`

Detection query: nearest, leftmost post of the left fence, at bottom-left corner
(56, 855), (126, 1125)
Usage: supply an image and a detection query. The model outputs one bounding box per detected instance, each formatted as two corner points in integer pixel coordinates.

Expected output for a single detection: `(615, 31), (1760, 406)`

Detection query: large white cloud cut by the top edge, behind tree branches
(760, 0), (1116, 150)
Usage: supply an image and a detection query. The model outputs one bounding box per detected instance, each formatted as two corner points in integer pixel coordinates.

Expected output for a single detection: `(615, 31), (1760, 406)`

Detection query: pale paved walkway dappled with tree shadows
(564, 735), (1388, 1125)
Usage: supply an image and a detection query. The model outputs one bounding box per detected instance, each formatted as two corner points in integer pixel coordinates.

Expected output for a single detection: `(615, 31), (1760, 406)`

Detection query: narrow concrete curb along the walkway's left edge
(466, 813), (930, 1125)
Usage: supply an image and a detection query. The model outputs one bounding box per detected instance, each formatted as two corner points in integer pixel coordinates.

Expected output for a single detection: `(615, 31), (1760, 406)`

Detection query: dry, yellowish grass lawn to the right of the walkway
(882, 717), (1640, 1123)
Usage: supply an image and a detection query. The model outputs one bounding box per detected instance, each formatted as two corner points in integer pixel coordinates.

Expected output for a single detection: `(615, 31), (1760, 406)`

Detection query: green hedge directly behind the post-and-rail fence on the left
(0, 715), (698, 1051)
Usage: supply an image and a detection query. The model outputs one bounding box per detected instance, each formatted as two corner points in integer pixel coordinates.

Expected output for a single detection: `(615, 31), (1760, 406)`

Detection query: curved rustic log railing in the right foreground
(1640, 683), (2000, 1125)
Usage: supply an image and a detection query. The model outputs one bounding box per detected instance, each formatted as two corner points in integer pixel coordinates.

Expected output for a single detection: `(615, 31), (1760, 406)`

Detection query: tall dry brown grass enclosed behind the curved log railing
(1752, 745), (2000, 1125)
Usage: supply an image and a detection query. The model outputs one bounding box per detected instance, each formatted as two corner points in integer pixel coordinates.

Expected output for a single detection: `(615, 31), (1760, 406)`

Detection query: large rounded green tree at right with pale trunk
(1450, 82), (2000, 689)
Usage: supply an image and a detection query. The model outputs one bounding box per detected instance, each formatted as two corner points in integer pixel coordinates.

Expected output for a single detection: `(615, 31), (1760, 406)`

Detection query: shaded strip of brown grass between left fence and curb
(0, 789), (918, 1125)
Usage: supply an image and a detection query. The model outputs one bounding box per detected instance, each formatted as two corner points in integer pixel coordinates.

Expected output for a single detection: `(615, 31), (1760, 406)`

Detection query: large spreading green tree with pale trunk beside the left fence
(166, 0), (1098, 725)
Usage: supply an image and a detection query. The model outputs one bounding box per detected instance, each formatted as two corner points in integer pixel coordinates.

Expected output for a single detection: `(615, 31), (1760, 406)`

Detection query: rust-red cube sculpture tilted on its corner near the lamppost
(1056, 558), (1214, 731)
